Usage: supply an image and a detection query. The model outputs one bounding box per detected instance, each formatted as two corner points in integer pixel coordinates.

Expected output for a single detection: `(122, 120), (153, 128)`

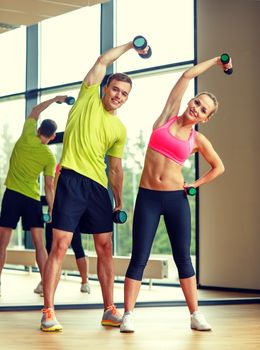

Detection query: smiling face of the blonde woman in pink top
(185, 94), (215, 124)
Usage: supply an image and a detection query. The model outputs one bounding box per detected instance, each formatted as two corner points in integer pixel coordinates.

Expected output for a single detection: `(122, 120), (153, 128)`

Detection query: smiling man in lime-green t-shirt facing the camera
(41, 42), (149, 332)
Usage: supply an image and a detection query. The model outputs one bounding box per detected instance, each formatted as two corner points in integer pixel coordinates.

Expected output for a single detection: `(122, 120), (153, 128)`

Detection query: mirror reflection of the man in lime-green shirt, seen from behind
(0, 96), (67, 294)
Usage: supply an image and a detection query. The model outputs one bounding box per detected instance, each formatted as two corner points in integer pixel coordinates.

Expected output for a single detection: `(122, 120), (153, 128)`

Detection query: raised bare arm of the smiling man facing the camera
(84, 41), (133, 85)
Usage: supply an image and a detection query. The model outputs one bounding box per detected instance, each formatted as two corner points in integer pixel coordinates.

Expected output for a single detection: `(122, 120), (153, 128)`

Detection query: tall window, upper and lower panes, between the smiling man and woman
(114, 0), (195, 282)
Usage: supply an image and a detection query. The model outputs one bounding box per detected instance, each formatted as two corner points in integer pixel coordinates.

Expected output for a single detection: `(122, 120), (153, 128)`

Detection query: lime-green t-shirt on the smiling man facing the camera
(60, 82), (126, 187)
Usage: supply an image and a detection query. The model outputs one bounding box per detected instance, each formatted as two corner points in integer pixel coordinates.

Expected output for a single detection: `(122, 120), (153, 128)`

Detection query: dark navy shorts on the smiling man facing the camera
(52, 169), (113, 233)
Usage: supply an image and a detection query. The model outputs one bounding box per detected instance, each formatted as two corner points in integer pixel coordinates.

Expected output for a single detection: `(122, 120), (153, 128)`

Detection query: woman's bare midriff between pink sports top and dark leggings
(140, 148), (184, 191)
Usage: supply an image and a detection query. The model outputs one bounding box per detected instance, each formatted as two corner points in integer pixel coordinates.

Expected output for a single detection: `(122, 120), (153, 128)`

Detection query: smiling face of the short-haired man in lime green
(102, 79), (131, 112)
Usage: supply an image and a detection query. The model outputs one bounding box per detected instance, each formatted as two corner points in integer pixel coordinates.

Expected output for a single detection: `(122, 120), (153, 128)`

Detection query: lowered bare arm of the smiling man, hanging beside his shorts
(108, 156), (123, 210)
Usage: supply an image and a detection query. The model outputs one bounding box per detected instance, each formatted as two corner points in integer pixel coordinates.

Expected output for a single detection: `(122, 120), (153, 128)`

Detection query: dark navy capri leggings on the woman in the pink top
(126, 188), (195, 281)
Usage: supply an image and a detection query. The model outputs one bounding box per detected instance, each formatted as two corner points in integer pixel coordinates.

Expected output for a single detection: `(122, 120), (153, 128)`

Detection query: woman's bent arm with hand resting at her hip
(188, 133), (225, 187)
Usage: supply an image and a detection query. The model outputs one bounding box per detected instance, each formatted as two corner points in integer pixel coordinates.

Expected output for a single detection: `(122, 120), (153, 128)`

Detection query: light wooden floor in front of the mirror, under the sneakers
(0, 304), (260, 350)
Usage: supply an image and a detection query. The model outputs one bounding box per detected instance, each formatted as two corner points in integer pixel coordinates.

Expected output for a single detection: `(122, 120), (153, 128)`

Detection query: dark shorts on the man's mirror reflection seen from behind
(0, 188), (43, 230)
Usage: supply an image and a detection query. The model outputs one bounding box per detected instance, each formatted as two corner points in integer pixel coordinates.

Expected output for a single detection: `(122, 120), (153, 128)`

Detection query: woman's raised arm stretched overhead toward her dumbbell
(153, 57), (223, 129)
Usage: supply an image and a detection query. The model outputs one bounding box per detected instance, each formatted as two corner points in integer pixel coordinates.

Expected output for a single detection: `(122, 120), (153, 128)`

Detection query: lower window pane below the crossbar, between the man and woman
(116, 71), (195, 282)
